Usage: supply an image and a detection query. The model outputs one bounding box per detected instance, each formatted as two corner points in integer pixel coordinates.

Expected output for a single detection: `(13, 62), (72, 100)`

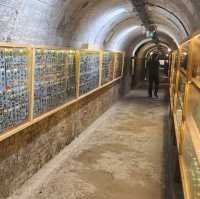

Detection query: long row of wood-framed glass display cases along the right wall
(170, 35), (200, 199)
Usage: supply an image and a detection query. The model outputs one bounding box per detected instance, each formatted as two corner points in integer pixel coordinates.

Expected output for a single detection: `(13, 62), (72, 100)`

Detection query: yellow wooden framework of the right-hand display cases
(170, 34), (200, 199)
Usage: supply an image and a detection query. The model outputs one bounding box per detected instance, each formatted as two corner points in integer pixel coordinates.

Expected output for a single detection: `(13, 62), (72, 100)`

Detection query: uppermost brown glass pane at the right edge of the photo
(192, 38), (200, 81)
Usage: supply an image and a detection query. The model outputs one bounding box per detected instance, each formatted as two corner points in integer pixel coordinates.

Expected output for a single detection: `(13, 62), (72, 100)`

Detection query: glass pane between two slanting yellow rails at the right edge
(189, 85), (200, 130)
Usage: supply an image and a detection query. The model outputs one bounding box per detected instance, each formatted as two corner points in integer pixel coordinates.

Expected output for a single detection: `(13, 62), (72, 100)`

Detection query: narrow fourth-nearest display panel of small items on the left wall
(101, 51), (115, 85)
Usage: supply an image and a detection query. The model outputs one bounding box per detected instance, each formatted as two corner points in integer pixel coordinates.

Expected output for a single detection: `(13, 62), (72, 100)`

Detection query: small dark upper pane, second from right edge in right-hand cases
(180, 43), (189, 71)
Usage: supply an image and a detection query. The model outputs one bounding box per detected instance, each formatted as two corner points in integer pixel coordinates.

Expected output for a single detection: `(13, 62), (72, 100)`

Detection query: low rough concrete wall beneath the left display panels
(0, 82), (120, 199)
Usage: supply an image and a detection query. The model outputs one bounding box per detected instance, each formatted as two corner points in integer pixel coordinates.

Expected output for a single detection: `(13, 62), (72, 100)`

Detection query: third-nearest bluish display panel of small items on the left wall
(80, 50), (100, 96)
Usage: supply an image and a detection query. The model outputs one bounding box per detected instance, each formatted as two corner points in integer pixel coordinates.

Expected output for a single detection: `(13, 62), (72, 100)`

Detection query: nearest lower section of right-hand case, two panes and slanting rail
(180, 83), (200, 199)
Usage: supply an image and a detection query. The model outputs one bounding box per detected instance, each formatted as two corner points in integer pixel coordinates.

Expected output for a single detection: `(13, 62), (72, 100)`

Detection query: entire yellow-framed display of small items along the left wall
(0, 43), (123, 141)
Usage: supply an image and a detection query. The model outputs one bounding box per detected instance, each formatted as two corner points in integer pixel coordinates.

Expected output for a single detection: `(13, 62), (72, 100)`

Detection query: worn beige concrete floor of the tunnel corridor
(10, 90), (168, 199)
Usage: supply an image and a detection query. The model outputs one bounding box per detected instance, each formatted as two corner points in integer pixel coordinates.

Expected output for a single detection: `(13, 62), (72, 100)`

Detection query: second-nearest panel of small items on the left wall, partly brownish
(34, 49), (76, 117)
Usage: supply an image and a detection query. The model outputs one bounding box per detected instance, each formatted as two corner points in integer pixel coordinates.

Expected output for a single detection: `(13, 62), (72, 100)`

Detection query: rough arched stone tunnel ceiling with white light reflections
(0, 0), (200, 50)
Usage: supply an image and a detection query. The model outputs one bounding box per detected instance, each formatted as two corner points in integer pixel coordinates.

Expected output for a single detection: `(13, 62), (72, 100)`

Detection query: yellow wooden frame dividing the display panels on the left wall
(0, 43), (125, 142)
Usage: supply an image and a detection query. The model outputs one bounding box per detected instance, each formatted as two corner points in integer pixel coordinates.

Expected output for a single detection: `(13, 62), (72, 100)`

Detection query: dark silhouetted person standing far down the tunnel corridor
(148, 53), (160, 98)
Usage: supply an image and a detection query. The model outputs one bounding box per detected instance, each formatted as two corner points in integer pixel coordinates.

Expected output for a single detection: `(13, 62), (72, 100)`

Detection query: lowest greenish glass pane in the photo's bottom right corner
(183, 127), (200, 199)
